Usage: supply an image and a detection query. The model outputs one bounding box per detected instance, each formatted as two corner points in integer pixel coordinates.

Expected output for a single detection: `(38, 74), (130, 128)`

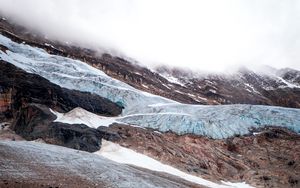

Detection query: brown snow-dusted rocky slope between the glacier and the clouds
(0, 19), (300, 108)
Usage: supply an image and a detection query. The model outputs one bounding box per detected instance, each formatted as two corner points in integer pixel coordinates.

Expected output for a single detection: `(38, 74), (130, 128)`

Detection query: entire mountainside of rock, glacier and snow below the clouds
(0, 15), (300, 188)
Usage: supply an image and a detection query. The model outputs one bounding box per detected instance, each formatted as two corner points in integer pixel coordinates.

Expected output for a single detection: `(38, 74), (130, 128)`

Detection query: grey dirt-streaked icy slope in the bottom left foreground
(0, 141), (202, 188)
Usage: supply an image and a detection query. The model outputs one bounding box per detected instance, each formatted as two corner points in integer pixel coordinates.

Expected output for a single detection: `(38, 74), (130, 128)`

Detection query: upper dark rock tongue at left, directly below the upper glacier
(0, 61), (122, 122)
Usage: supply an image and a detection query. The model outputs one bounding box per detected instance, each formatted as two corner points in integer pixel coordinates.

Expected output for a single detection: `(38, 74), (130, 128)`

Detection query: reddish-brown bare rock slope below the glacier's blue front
(102, 124), (300, 187)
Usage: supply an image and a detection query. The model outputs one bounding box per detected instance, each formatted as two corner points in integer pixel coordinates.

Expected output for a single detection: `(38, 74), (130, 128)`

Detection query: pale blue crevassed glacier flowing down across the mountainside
(0, 35), (300, 139)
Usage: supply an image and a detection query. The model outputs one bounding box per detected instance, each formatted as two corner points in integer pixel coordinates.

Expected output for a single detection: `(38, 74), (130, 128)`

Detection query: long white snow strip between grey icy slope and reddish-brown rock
(95, 140), (251, 188)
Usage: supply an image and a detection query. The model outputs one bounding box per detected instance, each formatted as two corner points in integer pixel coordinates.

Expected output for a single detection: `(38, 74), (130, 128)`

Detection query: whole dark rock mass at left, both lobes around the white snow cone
(0, 61), (122, 152)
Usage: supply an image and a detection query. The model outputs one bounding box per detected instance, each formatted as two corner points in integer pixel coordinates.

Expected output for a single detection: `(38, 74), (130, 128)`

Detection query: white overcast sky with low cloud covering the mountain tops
(0, 0), (300, 71)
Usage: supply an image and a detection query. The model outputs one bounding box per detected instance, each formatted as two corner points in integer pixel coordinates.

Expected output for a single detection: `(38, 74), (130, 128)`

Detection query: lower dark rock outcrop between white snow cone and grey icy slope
(12, 104), (102, 152)
